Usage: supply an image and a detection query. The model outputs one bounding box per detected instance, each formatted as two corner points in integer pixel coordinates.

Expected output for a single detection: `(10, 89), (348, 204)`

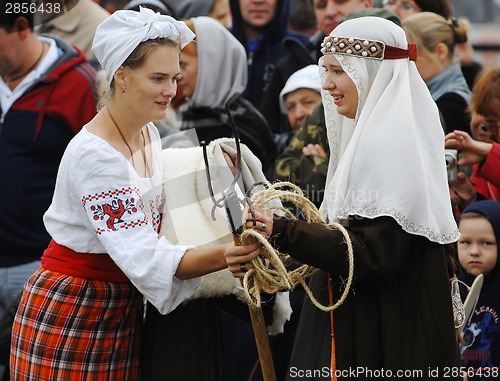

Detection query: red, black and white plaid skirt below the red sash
(10, 268), (144, 381)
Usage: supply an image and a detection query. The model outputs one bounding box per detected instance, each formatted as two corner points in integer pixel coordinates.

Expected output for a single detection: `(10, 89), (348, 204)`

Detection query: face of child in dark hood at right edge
(458, 217), (498, 276)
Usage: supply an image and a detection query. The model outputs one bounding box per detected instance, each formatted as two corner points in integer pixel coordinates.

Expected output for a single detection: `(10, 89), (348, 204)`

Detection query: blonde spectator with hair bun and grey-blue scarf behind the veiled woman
(403, 12), (471, 133)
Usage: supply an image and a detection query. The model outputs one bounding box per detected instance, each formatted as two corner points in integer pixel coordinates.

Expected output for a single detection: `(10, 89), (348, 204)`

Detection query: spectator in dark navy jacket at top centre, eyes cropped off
(230, 0), (308, 108)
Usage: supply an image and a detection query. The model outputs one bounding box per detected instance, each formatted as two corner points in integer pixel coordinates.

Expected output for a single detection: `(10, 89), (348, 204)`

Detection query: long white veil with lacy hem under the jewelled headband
(320, 17), (459, 243)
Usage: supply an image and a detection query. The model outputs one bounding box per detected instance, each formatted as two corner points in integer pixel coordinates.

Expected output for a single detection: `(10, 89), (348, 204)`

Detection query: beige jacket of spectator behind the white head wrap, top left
(37, 0), (109, 60)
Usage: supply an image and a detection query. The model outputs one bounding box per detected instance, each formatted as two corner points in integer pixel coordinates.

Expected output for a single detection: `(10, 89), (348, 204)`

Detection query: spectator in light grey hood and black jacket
(175, 16), (276, 171)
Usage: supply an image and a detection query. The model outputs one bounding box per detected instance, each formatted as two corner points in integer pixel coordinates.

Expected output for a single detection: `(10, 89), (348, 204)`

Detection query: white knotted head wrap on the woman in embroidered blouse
(92, 7), (195, 83)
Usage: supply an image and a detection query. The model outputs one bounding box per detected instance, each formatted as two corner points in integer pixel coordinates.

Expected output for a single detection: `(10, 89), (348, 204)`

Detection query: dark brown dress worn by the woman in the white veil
(273, 217), (460, 380)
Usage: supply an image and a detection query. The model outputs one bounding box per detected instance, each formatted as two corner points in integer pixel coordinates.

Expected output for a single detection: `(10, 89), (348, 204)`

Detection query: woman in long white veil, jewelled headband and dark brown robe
(227, 17), (460, 380)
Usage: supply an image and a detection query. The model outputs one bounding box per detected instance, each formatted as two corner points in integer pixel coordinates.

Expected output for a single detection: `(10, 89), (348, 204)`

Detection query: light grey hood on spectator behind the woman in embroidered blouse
(186, 16), (248, 108)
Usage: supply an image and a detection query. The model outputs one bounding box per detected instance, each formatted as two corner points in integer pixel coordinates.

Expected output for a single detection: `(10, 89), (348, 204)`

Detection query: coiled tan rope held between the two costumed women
(239, 182), (354, 312)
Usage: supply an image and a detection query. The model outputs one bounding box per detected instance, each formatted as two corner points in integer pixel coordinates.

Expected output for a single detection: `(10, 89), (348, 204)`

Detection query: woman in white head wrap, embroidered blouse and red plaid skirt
(10, 8), (259, 381)
